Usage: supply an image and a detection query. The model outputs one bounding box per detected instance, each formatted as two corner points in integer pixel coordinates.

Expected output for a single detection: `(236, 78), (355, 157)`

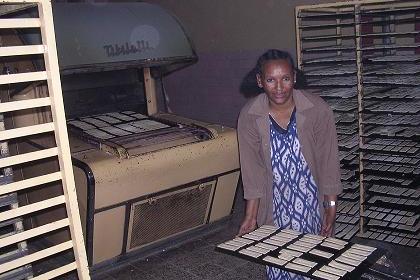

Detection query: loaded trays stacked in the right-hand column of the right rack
(359, 59), (420, 247)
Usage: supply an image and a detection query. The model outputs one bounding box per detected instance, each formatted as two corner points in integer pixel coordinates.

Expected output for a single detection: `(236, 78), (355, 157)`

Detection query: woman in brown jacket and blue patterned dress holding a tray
(238, 50), (342, 279)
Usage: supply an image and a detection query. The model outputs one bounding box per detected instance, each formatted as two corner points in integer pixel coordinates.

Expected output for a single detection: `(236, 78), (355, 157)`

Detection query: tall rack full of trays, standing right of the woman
(296, 0), (420, 247)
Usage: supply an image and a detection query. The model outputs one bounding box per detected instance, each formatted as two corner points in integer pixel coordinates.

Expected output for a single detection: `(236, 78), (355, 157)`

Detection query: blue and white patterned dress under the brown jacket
(267, 110), (321, 280)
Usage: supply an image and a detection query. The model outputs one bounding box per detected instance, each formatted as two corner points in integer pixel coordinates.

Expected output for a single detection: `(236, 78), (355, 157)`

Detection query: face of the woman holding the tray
(257, 59), (295, 106)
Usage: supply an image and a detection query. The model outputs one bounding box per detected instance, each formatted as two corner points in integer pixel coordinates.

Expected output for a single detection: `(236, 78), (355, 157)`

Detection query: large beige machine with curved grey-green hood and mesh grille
(9, 3), (239, 266)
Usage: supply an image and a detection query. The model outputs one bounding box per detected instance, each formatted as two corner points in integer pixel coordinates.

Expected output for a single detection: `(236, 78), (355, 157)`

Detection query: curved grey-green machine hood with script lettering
(53, 3), (197, 74)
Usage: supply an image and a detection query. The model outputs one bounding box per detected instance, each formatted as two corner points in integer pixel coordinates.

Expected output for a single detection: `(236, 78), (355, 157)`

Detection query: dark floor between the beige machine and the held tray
(92, 221), (265, 280)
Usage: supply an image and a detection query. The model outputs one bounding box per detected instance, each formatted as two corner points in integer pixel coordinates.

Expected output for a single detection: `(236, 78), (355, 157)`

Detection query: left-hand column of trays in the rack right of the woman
(296, 6), (360, 240)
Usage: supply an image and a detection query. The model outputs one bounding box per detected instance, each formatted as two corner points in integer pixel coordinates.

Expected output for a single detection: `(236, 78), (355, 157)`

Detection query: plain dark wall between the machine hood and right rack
(146, 0), (332, 126)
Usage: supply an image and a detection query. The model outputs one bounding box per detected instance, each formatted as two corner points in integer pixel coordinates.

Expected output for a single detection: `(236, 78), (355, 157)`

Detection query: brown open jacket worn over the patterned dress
(238, 90), (342, 225)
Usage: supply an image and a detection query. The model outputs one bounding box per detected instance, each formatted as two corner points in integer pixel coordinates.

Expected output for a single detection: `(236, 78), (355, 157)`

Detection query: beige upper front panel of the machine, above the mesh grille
(70, 114), (239, 209)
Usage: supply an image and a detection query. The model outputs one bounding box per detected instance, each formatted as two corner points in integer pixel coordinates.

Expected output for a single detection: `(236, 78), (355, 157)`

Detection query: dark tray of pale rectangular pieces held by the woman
(216, 228), (381, 280)
